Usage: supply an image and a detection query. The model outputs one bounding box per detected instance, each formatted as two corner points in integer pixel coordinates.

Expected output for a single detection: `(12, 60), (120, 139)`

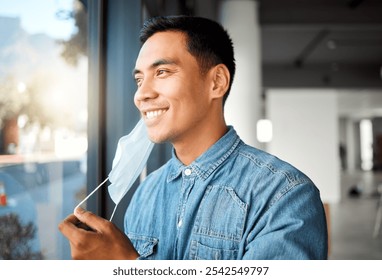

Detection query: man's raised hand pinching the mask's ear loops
(58, 208), (139, 260)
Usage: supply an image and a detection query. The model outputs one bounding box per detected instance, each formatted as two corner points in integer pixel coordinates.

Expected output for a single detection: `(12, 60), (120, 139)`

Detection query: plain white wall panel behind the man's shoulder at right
(267, 89), (341, 203)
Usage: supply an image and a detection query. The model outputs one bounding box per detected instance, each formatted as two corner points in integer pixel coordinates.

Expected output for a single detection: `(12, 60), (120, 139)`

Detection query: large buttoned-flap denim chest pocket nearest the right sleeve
(190, 186), (247, 259)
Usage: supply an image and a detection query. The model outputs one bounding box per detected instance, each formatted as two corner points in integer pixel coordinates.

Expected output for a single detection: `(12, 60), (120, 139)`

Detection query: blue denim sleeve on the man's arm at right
(243, 183), (328, 260)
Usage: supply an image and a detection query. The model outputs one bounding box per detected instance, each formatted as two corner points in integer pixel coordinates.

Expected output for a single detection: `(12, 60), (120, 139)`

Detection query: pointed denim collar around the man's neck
(167, 126), (241, 182)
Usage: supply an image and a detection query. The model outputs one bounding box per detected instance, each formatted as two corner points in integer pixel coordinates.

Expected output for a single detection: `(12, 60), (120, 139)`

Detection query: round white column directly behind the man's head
(219, 0), (263, 148)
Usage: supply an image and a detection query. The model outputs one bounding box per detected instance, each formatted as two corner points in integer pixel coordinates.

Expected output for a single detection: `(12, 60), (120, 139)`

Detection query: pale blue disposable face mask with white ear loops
(76, 119), (154, 221)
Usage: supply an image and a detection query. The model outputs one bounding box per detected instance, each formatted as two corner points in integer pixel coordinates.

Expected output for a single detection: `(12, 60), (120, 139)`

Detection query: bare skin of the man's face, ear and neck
(134, 31), (230, 165)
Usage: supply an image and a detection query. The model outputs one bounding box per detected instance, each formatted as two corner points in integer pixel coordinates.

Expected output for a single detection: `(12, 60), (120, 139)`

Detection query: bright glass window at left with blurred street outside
(0, 0), (87, 259)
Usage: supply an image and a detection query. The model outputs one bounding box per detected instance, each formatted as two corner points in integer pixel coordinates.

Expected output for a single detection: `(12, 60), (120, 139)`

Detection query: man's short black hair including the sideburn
(139, 16), (236, 104)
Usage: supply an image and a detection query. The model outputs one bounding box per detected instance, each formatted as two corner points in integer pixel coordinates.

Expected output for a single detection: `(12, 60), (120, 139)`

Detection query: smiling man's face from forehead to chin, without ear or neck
(134, 31), (211, 144)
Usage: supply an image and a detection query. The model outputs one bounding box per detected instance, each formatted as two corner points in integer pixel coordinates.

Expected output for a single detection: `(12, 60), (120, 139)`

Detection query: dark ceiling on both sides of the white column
(144, 0), (382, 117)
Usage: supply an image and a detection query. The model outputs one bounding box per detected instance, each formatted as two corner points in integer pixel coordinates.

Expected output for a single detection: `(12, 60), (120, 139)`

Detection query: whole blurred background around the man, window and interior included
(0, 0), (382, 260)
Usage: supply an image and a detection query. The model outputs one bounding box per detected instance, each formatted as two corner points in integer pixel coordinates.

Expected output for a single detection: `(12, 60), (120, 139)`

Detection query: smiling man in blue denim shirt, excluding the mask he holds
(59, 16), (327, 259)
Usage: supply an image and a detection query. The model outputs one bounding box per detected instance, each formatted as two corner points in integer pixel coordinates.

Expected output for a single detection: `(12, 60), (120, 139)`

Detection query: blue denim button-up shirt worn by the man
(125, 127), (327, 260)
